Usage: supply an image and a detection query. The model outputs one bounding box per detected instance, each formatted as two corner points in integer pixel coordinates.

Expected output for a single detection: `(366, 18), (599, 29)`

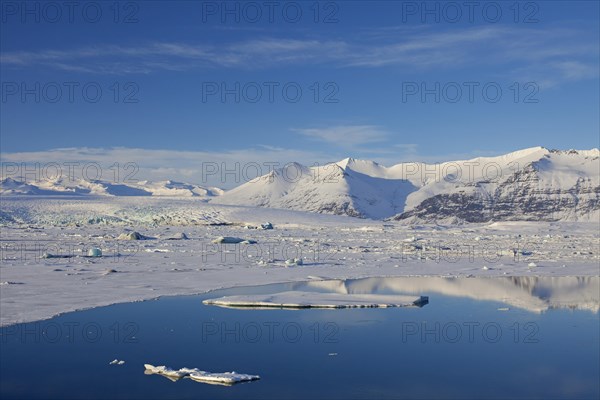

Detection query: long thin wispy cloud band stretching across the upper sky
(0, 26), (598, 86)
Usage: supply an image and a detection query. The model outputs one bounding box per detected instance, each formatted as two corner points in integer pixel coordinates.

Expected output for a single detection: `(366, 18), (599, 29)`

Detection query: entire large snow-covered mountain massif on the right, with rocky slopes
(212, 147), (600, 222)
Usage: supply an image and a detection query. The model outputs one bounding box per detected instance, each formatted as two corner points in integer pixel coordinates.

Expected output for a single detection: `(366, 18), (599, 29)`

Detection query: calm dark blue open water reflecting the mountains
(0, 277), (600, 399)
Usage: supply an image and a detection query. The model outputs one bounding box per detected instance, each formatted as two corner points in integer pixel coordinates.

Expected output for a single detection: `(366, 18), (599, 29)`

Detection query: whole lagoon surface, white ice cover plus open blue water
(0, 197), (600, 398)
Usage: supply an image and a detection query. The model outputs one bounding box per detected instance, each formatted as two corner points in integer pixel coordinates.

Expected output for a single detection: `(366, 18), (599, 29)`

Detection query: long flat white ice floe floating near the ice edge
(203, 291), (429, 308)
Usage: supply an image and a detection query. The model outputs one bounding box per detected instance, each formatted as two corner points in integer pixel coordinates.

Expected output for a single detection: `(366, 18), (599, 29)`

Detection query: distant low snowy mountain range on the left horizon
(0, 177), (223, 197)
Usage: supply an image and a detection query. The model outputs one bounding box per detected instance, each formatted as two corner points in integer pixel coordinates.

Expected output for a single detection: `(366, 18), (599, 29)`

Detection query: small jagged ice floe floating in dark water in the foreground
(144, 364), (260, 386)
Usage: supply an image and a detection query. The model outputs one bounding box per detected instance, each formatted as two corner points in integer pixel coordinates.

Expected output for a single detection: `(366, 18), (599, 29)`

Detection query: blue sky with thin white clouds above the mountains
(0, 1), (600, 181)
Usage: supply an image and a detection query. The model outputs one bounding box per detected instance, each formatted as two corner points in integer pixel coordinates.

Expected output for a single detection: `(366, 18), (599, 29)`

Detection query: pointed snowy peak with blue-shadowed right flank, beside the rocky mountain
(214, 159), (416, 219)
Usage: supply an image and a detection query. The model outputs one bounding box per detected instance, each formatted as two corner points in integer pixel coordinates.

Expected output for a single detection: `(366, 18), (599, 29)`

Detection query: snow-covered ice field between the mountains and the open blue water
(0, 196), (600, 326)
